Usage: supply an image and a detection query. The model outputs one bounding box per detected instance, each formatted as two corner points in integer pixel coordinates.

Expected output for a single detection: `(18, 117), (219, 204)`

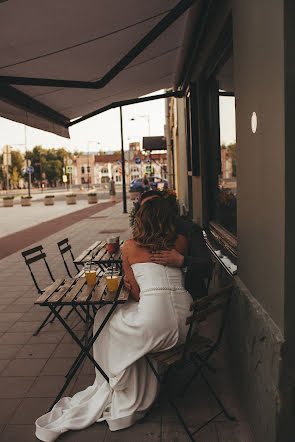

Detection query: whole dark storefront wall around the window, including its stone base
(183, 0), (294, 442)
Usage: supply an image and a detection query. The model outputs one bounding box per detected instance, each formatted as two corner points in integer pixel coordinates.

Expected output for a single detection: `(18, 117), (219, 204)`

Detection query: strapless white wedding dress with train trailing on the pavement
(36, 263), (192, 442)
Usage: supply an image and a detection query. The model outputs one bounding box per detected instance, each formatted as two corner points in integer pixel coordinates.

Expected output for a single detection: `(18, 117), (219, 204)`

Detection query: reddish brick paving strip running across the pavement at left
(0, 201), (118, 259)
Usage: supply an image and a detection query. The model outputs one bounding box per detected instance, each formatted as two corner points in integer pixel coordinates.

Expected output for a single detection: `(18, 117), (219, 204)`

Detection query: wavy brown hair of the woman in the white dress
(133, 198), (177, 250)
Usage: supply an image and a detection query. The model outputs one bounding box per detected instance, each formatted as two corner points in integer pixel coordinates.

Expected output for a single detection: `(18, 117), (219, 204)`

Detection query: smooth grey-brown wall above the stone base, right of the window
(233, 0), (285, 331)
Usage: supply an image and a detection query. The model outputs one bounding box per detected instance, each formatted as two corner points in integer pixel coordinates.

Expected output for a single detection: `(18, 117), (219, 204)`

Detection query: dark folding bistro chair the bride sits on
(145, 286), (235, 441)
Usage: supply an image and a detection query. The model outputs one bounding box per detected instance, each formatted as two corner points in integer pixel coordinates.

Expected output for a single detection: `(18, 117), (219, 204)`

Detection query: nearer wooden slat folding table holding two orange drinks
(35, 275), (129, 410)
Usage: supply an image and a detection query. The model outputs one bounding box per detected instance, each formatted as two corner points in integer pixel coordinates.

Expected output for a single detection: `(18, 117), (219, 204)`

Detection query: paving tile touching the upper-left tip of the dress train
(8, 398), (53, 425)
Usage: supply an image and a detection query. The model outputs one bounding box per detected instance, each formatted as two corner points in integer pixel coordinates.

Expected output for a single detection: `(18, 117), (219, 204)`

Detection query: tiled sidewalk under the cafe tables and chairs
(0, 202), (253, 442)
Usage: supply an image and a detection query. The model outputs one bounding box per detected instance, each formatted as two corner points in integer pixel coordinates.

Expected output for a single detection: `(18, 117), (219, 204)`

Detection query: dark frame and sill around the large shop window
(198, 15), (238, 264)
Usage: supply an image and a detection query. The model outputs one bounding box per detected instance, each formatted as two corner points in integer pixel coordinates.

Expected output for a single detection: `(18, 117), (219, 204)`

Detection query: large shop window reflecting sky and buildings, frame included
(199, 17), (238, 271)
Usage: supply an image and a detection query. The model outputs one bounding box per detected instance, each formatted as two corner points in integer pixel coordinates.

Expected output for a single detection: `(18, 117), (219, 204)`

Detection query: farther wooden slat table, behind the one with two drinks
(74, 241), (124, 270)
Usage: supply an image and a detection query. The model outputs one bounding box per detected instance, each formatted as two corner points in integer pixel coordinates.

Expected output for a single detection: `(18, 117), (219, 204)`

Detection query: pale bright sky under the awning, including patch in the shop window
(0, 91), (235, 153)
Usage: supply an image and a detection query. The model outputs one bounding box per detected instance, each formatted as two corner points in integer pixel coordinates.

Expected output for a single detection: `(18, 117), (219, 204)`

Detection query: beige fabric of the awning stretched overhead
(0, 0), (192, 136)
